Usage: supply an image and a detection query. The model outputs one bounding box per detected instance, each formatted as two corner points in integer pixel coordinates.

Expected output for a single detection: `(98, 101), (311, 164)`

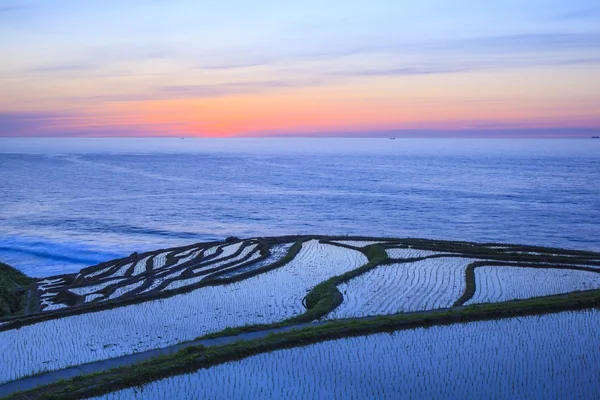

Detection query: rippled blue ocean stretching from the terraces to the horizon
(0, 138), (600, 277)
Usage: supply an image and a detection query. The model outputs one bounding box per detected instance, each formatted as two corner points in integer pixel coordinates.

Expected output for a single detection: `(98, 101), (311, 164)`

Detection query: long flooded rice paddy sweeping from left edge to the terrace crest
(0, 240), (367, 382)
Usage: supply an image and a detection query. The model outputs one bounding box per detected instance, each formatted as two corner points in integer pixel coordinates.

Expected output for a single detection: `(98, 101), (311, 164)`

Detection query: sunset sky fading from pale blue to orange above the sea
(0, 0), (600, 137)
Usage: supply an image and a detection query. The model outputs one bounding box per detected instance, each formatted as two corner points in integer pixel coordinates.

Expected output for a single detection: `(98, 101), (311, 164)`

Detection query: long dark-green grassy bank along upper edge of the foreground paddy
(7, 290), (600, 399)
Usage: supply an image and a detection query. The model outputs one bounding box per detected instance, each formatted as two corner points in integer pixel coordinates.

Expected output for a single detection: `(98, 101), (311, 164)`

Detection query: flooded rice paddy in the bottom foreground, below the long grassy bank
(90, 310), (600, 400)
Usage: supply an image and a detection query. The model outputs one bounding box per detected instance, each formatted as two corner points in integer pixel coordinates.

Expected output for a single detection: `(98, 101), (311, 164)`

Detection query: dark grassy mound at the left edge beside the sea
(0, 262), (35, 318)
